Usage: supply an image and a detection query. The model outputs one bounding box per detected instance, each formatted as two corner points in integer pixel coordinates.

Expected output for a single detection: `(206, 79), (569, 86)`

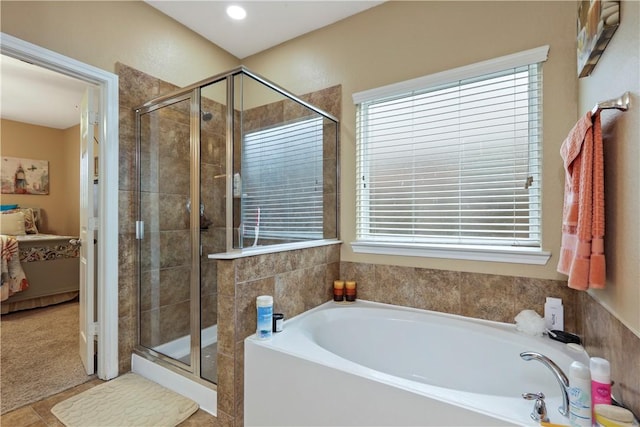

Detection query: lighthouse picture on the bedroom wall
(0, 157), (49, 195)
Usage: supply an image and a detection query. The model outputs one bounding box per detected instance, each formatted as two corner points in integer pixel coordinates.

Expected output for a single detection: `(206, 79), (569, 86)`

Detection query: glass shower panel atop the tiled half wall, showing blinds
(234, 75), (337, 248)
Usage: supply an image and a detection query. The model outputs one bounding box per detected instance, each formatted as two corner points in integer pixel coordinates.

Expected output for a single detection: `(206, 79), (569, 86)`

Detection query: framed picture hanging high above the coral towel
(577, 0), (620, 77)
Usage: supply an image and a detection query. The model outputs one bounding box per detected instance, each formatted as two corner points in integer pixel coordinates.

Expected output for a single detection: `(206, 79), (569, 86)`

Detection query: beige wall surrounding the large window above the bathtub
(244, 1), (577, 279)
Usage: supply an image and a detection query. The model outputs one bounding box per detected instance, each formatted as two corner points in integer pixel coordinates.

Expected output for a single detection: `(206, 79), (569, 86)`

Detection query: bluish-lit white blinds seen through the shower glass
(242, 117), (323, 241)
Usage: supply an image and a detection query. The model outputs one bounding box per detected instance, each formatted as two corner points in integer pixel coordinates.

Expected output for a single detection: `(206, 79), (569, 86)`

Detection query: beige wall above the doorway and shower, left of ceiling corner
(0, 0), (239, 86)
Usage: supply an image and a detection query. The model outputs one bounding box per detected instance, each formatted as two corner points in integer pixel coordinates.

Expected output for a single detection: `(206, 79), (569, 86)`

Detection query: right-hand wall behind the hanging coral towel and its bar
(578, 1), (640, 336)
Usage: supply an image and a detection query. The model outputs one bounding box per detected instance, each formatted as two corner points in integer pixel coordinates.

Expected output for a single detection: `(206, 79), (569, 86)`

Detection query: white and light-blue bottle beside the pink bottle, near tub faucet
(567, 361), (592, 427)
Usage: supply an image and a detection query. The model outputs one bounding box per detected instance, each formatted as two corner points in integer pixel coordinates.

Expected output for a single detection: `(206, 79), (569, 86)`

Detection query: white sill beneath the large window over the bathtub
(351, 241), (551, 265)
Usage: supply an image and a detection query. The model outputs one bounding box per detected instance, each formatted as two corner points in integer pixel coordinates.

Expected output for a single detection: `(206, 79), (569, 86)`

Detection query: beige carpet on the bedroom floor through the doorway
(0, 302), (93, 414)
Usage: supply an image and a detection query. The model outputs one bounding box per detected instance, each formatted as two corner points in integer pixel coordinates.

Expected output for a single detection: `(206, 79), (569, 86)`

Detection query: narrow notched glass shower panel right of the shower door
(200, 80), (227, 383)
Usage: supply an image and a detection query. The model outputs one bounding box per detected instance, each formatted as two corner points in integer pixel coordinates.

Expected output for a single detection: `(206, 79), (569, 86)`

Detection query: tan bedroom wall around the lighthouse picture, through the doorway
(0, 120), (80, 236)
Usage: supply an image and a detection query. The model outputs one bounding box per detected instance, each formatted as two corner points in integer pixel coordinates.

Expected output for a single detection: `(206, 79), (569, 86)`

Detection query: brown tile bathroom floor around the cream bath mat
(0, 379), (219, 427)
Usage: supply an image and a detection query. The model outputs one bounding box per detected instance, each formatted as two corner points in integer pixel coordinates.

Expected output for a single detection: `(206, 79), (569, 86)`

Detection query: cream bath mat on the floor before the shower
(51, 373), (198, 427)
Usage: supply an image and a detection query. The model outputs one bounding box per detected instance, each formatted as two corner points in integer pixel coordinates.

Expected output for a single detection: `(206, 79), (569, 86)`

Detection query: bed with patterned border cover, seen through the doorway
(0, 207), (80, 314)
